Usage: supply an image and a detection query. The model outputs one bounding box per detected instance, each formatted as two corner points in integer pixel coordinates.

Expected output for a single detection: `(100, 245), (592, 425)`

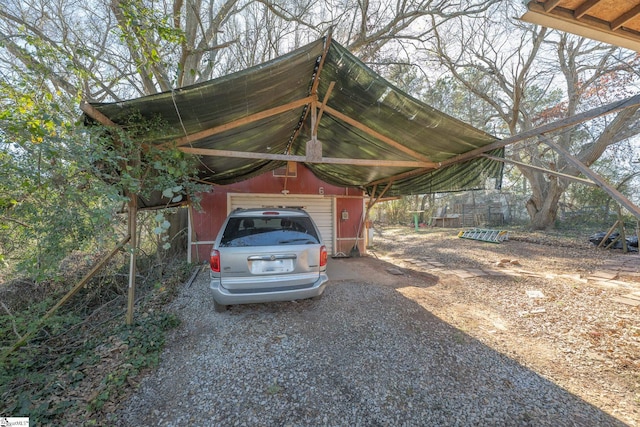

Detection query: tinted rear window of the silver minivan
(220, 215), (320, 247)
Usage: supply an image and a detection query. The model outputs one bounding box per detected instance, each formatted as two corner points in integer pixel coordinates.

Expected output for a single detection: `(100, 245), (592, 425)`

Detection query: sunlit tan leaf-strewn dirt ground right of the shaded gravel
(368, 227), (640, 426)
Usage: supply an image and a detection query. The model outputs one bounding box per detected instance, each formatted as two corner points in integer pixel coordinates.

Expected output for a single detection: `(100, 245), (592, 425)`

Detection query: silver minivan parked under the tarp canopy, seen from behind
(210, 208), (329, 312)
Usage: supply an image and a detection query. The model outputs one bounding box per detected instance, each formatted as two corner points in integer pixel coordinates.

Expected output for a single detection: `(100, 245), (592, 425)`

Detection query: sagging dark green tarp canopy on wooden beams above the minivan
(85, 38), (504, 201)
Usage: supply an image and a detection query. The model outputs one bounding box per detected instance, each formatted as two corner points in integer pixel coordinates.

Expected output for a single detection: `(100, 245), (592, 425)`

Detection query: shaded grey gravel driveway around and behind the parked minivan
(112, 257), (625, 426)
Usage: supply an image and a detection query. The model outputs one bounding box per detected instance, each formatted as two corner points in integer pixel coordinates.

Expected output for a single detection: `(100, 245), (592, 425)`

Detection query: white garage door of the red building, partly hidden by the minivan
(227, 193), (335, 254)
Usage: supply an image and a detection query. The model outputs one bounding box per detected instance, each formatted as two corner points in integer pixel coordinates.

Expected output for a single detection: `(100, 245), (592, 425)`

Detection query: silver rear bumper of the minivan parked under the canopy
(209, 271), (329, 305)
